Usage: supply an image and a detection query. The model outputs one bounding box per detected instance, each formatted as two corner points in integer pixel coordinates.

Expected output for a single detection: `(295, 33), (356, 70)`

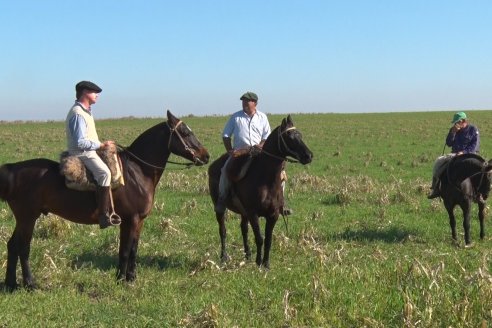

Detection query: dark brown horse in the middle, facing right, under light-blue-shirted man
(208, 115), (313, 268)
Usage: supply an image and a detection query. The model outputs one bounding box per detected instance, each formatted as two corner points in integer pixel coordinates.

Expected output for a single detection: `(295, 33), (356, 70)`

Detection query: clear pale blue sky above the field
(0, 0), (492, 120)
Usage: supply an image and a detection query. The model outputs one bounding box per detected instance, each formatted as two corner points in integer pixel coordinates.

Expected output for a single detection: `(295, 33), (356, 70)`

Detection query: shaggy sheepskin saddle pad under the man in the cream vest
(60, 145), (125, 191)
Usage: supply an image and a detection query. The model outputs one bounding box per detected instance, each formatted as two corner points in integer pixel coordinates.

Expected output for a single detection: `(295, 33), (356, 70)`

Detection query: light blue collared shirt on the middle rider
(222, 110), (270, 149)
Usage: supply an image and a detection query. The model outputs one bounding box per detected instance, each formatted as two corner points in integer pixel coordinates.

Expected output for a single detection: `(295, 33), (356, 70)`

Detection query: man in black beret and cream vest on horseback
(65, 81), (120, 229)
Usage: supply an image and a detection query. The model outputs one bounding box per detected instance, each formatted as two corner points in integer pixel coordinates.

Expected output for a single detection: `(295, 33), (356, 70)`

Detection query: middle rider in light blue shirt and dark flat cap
(215, 92), (292, 215)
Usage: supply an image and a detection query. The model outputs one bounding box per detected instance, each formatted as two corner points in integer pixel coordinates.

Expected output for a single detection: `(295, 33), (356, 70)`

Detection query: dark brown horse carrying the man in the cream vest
(0, 111), (209, 289)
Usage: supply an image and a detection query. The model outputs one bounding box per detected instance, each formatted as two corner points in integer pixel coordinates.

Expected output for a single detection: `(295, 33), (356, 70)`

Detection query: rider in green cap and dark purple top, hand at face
(427, 112), (480, 201)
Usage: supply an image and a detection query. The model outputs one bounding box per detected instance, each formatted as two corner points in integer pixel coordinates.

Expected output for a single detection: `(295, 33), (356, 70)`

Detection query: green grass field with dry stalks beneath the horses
(0, 111), (492, 327)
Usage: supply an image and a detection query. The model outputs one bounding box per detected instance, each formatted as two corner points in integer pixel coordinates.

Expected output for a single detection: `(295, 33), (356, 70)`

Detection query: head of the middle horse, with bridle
(277, 115), (313, 164)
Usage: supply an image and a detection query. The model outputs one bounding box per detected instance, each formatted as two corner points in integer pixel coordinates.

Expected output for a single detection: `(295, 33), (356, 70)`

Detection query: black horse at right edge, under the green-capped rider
(441, 154), (492, 246)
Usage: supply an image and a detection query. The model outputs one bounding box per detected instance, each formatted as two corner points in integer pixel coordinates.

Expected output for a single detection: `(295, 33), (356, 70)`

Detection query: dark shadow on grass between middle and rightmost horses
(332, 227), (423, 243)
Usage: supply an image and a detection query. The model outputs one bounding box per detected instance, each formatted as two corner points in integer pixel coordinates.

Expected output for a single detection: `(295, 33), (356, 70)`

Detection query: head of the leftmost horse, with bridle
(167, 110), (210, 165)
